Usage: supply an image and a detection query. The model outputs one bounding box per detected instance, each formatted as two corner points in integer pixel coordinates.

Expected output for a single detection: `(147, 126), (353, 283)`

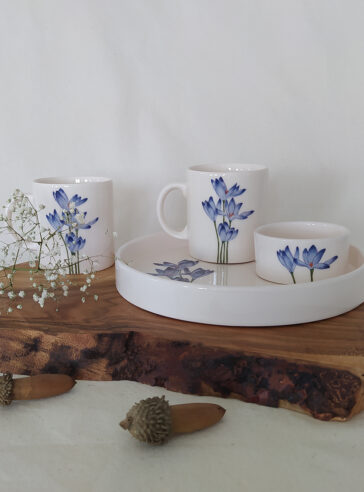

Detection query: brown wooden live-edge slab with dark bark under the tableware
(0, 268), (364, 421)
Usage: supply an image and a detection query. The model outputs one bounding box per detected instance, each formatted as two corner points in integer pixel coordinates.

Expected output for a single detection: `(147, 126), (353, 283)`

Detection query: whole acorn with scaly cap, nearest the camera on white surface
(120, 396), (225, 445)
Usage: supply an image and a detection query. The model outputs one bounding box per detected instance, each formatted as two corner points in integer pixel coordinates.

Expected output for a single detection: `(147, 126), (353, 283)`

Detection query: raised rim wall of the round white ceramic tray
(115, 232), (364, 327)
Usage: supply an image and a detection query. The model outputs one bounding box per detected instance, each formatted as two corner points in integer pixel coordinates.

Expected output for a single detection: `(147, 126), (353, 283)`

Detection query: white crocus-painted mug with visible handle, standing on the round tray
(157, 164), (268, 263)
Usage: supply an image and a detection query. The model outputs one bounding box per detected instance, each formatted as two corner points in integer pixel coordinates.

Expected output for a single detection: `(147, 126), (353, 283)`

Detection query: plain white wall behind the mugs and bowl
(0, 0), (364, 250)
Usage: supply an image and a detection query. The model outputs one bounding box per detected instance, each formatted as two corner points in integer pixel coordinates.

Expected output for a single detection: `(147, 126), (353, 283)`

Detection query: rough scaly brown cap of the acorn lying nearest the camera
(120, 396), (172, 444)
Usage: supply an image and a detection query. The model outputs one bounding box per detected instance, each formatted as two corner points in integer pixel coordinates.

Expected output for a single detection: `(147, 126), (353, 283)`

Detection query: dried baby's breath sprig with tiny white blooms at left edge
(0, 189), (96, 314)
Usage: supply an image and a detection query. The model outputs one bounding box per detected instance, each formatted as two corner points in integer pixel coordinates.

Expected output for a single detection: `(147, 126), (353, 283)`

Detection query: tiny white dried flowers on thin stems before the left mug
(0, 189), (101, 312)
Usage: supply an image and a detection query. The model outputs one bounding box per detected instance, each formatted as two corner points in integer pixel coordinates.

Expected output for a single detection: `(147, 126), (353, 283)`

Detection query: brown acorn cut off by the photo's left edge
(0, 373), (76, 406)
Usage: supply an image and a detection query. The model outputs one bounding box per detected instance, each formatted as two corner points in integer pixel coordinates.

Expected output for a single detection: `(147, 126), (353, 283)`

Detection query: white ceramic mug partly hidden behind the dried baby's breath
(8, 177), (114, 273)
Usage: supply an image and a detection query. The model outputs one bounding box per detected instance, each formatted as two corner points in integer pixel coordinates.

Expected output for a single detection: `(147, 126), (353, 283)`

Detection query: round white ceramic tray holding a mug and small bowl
(116, 233), (364, 326)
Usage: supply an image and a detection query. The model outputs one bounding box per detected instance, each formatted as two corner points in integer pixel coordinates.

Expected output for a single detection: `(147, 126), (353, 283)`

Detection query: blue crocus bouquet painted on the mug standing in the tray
(202, 176), (254, 263)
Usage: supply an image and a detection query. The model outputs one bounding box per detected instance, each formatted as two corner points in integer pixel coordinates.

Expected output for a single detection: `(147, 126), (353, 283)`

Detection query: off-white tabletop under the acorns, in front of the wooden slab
(0, 381), (364, 492)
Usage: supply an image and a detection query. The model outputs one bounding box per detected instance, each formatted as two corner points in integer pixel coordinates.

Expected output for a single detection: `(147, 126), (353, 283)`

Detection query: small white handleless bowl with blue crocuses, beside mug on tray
(254, 222), (350, 284)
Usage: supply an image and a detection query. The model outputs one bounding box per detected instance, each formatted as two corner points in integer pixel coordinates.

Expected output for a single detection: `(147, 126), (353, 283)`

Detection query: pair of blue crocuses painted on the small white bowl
(277, 244), (338, 283)
